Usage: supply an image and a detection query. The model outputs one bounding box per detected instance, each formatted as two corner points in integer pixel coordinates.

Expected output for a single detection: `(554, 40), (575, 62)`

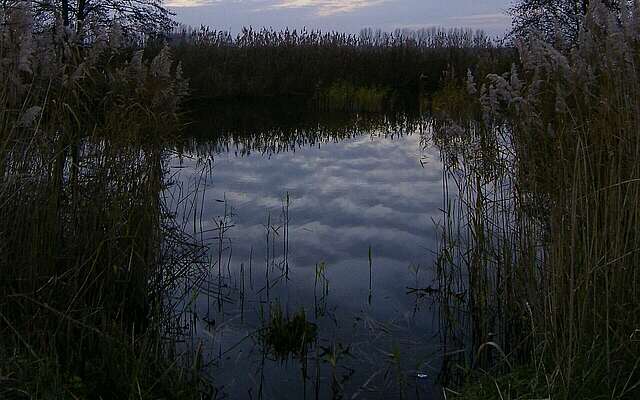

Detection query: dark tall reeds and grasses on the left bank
(0, 2), (208, 398)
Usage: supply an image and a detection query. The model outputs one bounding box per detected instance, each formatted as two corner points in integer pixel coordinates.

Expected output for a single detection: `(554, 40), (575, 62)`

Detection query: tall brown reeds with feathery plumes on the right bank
(435, 2), (640, 399)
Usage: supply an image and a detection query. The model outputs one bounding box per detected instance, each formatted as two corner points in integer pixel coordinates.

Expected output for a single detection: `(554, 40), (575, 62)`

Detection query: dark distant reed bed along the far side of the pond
(171, 27), (515, 103)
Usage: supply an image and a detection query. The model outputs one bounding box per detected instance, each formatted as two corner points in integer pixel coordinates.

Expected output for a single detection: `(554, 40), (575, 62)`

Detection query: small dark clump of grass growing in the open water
(263, 303), (318, 360)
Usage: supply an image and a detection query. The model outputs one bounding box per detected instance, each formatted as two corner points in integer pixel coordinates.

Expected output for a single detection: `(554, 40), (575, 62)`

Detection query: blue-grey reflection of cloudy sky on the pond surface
(171, 114), (442, 398)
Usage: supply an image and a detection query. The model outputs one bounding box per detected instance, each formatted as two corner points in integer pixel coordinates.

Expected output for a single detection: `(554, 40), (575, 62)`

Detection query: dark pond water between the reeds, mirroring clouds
(170, 104), (442, 399)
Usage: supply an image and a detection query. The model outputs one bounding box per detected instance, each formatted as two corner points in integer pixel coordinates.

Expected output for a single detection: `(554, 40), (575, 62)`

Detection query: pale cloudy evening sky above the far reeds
(165, 0), (511, 36)
